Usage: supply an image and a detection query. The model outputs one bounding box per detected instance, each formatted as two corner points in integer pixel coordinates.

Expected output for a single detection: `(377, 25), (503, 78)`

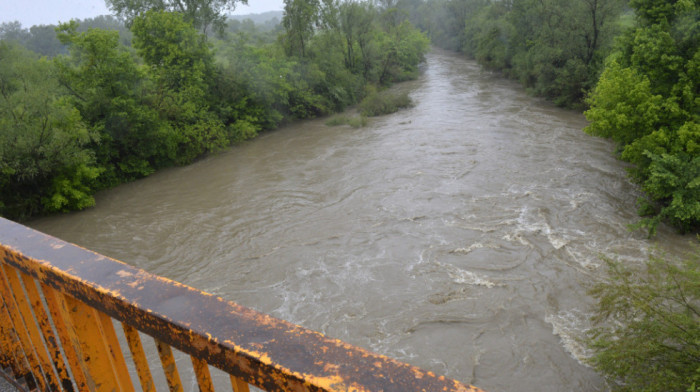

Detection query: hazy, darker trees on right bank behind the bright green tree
(402, 0), (625, 107)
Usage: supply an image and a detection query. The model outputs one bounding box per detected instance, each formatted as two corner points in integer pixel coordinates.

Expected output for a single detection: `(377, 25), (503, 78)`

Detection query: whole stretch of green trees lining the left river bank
(0, 0), (429, 219)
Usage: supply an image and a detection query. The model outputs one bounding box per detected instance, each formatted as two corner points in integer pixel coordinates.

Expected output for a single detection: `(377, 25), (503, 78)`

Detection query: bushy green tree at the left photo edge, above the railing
(0, 42), (100, 219)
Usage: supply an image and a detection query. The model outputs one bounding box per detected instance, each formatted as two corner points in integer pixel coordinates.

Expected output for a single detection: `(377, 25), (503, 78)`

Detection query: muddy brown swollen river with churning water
(30, 51), (688, 392)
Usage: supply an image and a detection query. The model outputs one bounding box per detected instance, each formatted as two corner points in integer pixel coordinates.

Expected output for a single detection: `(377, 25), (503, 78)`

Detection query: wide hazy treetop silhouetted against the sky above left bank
(105, 0), (248, 35)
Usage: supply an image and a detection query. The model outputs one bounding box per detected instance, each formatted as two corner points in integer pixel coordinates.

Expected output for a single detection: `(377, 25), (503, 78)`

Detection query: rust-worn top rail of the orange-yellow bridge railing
(0, 218), (486, 392)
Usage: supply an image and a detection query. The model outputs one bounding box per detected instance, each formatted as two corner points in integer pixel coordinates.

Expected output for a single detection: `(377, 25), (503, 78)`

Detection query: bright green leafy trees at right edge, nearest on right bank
(586, 0), (700, 234)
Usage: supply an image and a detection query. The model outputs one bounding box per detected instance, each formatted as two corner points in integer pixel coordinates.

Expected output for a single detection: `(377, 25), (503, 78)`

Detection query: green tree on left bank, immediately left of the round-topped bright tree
(55, 21), (174, 187)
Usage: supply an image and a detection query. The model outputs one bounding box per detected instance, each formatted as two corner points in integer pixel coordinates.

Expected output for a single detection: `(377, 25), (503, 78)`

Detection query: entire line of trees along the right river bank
(397, 0), (700, 234)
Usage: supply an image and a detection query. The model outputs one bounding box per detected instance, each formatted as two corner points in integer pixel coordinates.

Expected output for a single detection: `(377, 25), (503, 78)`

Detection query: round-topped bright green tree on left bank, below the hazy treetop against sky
(132, 11), (229, 164)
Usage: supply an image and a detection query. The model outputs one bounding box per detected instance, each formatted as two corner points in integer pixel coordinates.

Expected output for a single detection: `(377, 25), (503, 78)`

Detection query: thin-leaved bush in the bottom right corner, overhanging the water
(589, 249), (700, 392)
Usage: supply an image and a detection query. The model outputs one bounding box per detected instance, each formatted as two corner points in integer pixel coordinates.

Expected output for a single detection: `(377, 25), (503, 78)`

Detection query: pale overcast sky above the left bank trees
(0, 0), (283, 28)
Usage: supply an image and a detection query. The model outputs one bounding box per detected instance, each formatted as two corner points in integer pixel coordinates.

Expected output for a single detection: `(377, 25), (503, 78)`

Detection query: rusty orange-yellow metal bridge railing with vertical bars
(0, 218), (479, 392)
